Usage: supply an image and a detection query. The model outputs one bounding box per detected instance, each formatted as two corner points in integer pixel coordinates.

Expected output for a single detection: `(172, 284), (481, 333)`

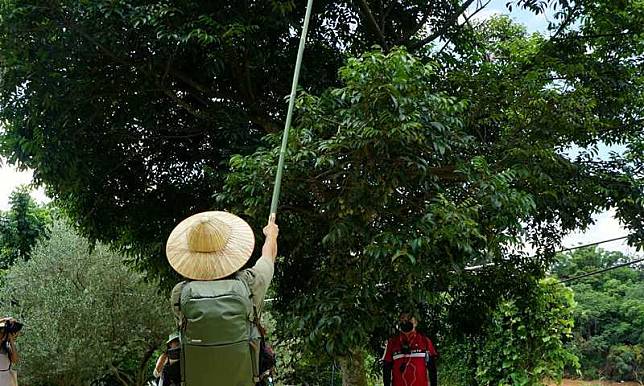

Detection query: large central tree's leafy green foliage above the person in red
(222, 45), (588, 381)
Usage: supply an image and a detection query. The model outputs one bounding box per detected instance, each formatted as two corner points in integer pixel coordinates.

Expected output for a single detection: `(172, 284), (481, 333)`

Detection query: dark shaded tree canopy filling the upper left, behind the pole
(0, 0), (494, 275)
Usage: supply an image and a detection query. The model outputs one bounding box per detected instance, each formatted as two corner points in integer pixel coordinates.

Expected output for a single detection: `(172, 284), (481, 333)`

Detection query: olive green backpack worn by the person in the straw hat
(179, 279), (261, 386)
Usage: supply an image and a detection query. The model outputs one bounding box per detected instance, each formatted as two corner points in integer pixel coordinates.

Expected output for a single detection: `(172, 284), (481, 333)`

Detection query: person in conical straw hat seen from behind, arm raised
(166, 211), (279, 386)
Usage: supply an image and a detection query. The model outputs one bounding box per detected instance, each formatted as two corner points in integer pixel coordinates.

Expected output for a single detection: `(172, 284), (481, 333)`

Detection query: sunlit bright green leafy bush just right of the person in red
(476, 279), (579, 386)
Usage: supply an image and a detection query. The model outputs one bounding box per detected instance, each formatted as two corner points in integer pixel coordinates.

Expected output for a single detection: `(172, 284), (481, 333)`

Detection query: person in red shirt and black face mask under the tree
(382, 313), (438, 386)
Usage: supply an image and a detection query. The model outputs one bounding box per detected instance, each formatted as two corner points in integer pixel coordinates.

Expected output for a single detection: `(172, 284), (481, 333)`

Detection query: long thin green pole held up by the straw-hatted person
(271, 0), (313, 220)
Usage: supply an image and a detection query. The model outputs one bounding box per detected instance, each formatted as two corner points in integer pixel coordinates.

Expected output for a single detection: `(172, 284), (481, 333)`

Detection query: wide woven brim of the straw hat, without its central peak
(165, 211), (255, 280)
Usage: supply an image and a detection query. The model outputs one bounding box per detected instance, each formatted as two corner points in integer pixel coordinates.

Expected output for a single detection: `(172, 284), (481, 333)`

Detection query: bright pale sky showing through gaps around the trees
(0, 0), (635, 254)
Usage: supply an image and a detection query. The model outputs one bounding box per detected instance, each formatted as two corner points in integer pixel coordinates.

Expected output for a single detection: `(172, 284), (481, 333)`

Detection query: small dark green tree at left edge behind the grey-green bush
(0, 187), (50, 268)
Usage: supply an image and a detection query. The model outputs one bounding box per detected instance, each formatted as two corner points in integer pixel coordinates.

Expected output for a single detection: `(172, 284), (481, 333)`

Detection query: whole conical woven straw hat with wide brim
(165, 211), (255, 280)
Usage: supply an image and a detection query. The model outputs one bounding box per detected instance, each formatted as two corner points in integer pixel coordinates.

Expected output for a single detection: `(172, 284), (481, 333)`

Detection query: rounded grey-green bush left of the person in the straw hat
(0, 220), (172, 386)
